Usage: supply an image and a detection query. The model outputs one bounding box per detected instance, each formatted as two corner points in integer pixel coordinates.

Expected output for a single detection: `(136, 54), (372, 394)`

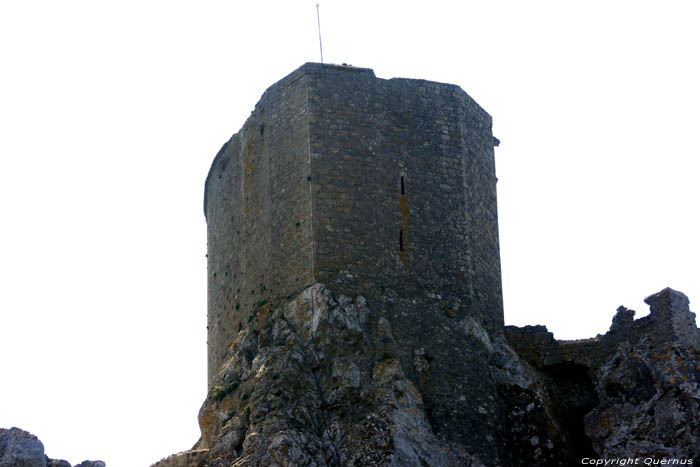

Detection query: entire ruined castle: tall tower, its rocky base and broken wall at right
(146, 63), (700, 467)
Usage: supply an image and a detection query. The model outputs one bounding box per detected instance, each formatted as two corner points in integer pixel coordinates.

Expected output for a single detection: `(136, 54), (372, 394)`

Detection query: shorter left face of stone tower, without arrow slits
(204, 67), (313, 382)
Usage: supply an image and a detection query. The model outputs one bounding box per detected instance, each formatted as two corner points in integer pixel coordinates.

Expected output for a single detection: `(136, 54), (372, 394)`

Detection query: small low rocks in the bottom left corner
(0, 428), (105, 467)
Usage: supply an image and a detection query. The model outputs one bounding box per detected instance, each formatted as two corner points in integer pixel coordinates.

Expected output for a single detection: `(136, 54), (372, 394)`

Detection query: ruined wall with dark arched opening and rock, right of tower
(506, 288), (700, 465)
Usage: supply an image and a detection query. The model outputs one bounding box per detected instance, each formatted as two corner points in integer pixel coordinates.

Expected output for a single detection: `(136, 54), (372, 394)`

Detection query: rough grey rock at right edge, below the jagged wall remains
(585, 339), (700, 463)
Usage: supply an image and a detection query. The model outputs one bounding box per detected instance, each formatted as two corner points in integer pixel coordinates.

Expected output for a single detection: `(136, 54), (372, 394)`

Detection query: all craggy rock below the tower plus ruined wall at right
(155, 284), (700, 467)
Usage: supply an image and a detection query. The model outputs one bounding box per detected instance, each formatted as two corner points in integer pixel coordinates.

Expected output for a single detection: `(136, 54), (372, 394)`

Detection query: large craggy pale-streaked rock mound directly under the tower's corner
(198, 284), (490, 466)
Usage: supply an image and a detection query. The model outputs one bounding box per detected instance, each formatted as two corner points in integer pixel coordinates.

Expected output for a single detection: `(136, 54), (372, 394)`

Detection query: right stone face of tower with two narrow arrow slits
(305, 65), (503, 456)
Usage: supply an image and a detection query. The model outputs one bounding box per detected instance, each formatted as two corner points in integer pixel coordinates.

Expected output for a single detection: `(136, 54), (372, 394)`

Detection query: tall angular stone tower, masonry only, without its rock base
(204, 63), (503, 452)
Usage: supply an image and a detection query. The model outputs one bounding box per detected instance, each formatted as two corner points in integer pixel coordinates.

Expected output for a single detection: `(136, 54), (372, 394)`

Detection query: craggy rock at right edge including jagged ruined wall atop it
(585, 289), (700, 464)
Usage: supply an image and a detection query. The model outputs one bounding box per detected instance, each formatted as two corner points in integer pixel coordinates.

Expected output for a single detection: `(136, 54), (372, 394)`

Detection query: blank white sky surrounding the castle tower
(0, 0), (700, 467)
